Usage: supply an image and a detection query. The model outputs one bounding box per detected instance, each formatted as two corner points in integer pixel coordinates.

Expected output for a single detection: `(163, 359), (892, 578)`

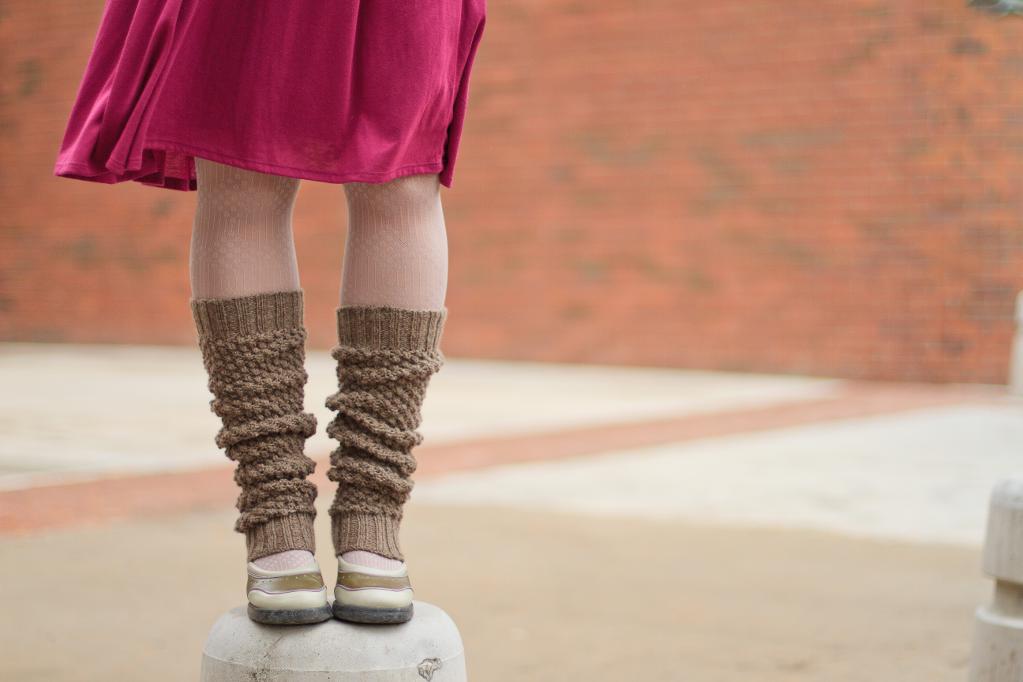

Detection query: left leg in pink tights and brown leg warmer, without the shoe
(189, 158), (316, 571)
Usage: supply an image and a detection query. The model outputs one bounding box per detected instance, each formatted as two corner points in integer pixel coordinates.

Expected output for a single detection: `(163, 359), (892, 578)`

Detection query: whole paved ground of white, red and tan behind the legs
(0, 345), (1023, 682)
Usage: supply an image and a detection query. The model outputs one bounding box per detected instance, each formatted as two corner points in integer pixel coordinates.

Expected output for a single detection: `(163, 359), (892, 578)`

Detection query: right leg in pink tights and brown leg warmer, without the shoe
(327, 174), (448, 569)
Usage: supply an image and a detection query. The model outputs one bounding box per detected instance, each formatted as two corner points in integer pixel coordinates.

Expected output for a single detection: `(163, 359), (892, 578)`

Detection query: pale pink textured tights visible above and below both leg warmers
(189, 158), (448, 571)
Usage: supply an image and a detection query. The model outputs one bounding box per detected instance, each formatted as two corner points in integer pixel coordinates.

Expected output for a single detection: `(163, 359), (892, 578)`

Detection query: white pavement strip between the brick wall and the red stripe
(0, 344), (843, 490)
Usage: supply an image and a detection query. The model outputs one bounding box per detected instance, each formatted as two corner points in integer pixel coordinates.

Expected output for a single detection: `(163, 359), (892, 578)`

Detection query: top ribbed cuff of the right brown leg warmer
(338, 306), (447, 351)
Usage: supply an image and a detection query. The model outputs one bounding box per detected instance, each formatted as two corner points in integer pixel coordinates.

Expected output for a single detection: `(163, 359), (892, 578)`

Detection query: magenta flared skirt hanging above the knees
(54, 0), (486, 190)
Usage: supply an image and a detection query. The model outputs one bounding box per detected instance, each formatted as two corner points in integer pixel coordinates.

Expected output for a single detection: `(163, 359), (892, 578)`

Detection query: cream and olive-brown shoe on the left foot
(246, 557), (331, 625)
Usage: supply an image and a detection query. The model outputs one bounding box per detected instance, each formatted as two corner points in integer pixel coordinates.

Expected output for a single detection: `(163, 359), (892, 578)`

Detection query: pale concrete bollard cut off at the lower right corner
(970, 479), (1023, 682)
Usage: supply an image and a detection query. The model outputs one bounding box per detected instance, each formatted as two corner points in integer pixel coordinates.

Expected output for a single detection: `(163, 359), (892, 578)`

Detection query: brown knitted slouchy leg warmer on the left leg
(190, 289), (316, 561)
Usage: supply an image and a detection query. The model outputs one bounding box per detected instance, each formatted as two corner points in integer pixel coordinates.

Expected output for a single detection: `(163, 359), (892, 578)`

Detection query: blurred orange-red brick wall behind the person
(0, 0), (1023, 383)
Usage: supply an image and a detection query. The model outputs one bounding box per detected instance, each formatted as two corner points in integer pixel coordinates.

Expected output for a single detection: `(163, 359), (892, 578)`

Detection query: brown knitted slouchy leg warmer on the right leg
(326, 306), (447, 560)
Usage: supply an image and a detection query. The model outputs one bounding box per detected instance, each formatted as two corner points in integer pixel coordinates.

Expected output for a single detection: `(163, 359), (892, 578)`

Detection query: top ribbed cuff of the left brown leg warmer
(189, 289), (303, 338)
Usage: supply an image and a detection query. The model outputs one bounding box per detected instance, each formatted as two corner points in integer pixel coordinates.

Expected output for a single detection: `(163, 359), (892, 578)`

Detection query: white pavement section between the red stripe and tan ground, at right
(412, 402), (1023, 545)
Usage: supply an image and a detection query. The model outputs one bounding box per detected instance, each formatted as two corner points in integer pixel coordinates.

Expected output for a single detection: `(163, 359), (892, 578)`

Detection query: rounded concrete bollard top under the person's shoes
(201, 601), (466, 682)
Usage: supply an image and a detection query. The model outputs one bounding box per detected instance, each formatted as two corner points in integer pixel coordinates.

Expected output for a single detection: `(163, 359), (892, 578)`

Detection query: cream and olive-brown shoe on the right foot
(333, 556), (413, 623)
